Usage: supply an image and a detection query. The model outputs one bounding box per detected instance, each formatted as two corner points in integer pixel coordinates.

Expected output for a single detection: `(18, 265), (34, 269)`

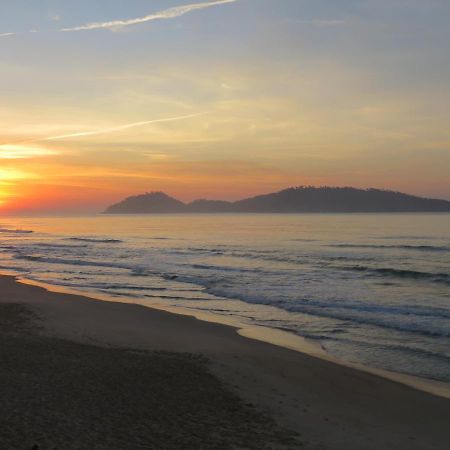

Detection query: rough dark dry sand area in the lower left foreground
(0, 303), (303, 450)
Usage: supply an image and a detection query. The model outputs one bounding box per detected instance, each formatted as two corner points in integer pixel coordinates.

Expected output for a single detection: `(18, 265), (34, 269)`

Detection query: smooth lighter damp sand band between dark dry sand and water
(0, 276), (450, 450)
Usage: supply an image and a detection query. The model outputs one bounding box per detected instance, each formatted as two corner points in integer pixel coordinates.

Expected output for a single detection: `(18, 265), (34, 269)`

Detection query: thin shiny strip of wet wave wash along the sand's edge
(12, 272), (450, 399)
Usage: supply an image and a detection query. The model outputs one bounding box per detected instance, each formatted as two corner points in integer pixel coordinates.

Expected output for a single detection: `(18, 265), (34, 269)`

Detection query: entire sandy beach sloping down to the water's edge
(0, 276), (450, 450)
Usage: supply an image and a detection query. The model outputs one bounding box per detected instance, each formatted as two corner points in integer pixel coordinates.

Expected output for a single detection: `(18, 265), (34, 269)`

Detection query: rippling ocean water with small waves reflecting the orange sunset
(0, 214), (450, 382)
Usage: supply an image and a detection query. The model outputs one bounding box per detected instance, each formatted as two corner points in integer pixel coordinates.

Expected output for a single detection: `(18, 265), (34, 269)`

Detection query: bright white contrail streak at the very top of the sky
(59, 0), (239, 31)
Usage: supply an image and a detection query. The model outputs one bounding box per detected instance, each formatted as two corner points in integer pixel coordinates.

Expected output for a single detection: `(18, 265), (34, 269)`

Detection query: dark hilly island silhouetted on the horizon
(104, 186), (450, 214)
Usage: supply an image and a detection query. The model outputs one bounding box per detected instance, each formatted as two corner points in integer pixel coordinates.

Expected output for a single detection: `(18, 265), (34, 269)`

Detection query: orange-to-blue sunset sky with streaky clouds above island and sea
(0, 0), (450, 213)
